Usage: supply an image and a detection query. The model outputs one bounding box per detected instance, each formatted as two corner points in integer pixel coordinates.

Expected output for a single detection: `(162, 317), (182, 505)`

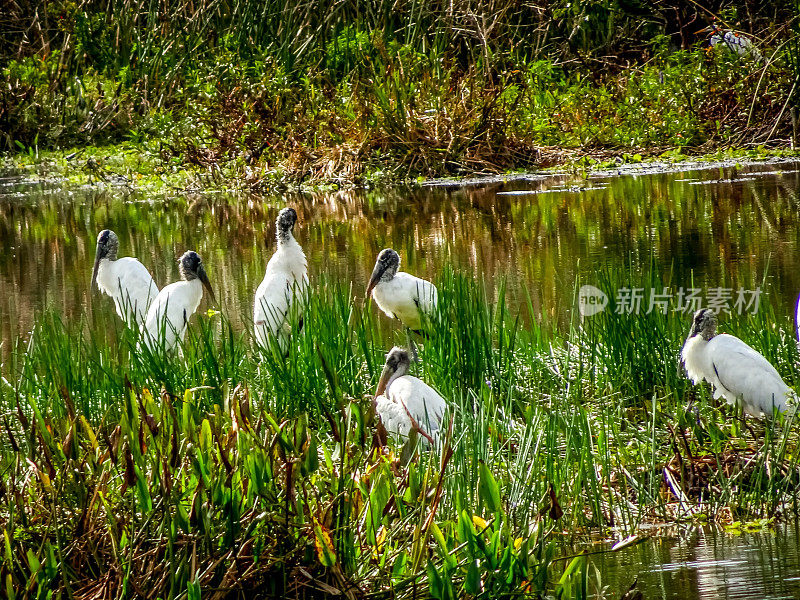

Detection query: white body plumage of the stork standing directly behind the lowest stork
(372, 271), (439, 329)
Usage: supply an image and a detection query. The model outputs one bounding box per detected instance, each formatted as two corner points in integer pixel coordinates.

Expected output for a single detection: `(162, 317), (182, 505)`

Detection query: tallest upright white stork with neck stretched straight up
(253, 208), (308, 352)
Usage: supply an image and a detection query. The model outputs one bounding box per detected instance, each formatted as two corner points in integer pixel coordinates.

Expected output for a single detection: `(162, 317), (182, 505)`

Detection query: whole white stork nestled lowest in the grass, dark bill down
(373, 346), (447, 444)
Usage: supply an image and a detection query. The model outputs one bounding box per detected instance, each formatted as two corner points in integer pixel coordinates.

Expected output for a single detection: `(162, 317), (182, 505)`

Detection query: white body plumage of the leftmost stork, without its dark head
(97, 257), (158, 328)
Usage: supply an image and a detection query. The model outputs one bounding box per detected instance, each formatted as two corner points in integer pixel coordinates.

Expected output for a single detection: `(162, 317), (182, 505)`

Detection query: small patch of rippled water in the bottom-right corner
(589, 524), (800, 600)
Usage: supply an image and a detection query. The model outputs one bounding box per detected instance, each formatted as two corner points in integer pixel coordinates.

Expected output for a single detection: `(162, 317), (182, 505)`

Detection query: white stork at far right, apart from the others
(681, 308), (795, 417)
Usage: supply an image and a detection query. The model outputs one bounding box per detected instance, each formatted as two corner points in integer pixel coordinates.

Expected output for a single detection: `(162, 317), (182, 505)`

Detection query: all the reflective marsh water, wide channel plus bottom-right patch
(0, 161), (800, 599)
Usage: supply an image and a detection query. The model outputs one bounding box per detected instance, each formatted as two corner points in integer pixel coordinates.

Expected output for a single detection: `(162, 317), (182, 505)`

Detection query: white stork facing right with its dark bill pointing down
(144, 250), (216, 351)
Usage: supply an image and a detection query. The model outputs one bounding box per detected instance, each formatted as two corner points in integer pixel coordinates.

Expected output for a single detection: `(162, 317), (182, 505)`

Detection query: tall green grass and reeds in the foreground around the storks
(0, 269), (800, 598)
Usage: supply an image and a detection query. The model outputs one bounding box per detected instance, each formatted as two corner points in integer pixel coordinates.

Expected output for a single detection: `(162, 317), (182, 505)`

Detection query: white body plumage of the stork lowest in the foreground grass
(375, 375), (447, 440)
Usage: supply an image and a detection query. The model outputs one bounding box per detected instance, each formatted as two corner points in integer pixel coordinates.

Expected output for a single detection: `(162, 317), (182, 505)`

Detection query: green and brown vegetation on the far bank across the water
(0, 0), (800, 191)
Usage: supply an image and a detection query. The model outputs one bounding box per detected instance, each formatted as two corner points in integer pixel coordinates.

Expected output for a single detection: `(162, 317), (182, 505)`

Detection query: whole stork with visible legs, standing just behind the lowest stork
(367, 248), (439, 360)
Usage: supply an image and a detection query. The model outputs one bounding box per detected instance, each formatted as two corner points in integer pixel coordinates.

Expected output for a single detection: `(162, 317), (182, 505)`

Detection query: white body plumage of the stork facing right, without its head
(144, 279), (203, 351)
